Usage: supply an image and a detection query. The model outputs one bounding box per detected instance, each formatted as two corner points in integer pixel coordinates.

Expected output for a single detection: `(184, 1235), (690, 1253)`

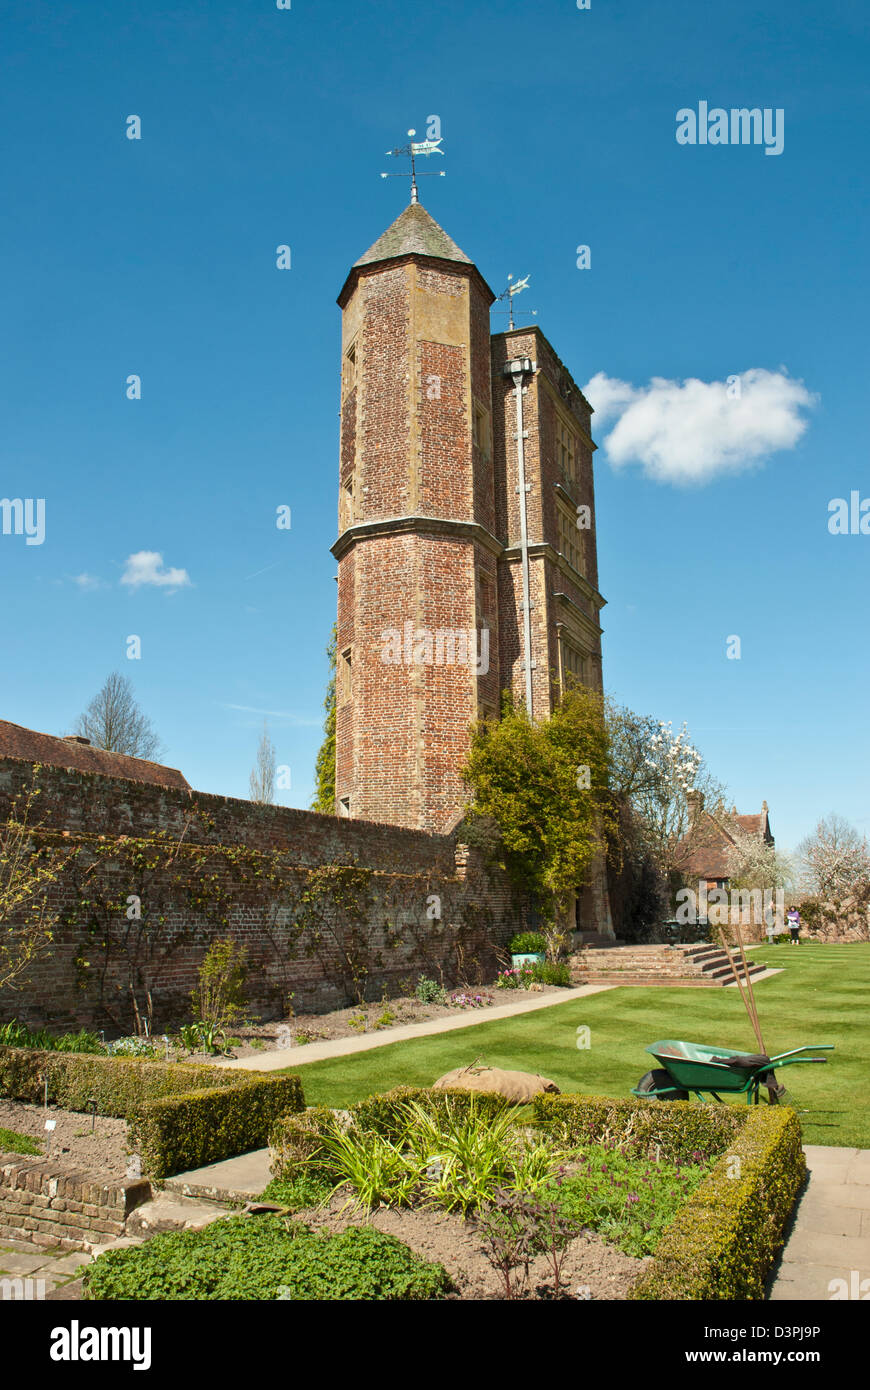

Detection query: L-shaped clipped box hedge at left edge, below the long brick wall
(0, 1047), (304, 1177)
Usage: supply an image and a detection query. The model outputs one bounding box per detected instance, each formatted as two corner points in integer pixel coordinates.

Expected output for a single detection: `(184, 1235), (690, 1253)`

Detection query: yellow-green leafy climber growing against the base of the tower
(463, 687), (613, 923)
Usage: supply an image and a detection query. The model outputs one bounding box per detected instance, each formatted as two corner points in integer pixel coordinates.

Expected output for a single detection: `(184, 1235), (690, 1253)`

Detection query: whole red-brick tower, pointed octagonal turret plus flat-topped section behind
(332, 203), (609, 930)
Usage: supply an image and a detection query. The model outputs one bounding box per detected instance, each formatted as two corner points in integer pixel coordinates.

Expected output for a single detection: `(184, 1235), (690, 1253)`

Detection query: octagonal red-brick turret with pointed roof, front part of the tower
(332, 203), (500, 831)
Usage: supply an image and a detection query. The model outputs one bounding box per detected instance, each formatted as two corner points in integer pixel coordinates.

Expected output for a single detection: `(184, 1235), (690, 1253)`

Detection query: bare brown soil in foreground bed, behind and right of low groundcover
(296, 1194), (649, 1301)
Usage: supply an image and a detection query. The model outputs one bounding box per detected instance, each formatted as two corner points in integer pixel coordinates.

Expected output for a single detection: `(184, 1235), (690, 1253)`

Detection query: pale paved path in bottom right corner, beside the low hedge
(767, 1144), (870, 1302)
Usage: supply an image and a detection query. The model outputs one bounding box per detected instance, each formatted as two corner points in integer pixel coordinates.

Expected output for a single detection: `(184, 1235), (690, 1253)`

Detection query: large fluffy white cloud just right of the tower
(582, 367), (817, 484)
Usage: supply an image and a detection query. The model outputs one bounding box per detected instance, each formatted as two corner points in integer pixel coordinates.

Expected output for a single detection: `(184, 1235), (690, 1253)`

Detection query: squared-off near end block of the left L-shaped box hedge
(128, 1072), (304, 1177)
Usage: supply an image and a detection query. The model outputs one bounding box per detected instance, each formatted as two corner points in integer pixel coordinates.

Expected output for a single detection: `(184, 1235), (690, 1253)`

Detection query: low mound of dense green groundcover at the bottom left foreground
(85, 1215), (450, 1302)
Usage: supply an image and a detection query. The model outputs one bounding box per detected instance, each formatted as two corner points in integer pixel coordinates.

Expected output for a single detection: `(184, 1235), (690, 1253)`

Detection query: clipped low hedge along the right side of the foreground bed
(628, 1102), (806, 1300)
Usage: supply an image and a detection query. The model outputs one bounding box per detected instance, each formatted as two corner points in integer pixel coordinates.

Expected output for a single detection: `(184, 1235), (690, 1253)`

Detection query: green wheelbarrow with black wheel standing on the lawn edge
(631, 1038), (834, 1105)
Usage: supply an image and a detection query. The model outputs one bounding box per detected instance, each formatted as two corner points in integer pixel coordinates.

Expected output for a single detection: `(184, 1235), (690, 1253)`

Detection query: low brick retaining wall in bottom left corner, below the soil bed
(0, 1154), (151, 1250)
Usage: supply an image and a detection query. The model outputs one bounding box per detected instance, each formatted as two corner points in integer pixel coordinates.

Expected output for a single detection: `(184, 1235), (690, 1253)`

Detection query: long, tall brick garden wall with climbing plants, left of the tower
(0, 759), (524, 1036)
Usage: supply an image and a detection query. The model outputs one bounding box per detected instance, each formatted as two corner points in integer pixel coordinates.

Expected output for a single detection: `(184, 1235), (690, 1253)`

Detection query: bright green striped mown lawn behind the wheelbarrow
(288, 942), (870, 1148)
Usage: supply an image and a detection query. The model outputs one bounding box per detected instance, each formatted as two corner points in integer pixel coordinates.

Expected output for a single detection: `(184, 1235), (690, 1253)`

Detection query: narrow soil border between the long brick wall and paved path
(179, 984), (564, 1062)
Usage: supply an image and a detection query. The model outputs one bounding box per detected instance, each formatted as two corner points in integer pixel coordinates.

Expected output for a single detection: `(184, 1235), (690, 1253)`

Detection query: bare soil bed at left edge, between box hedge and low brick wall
(0, 1101), (129, 1180)
